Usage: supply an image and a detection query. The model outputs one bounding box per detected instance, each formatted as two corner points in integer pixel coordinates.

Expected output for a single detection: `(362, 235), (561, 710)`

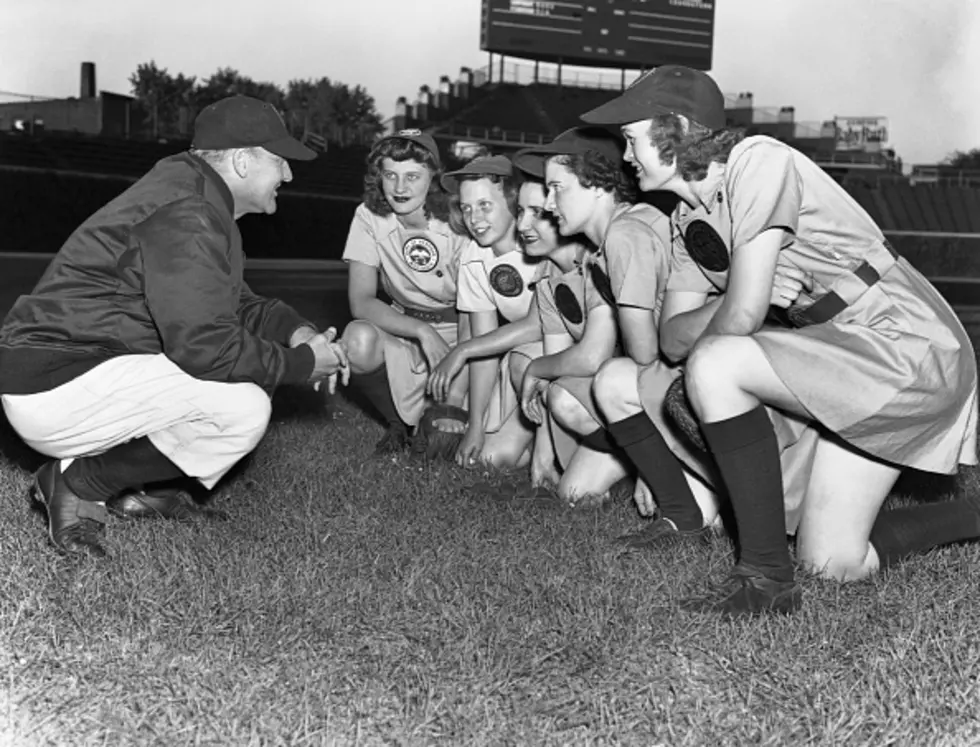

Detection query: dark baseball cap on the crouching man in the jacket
(191, 96), (316, 161)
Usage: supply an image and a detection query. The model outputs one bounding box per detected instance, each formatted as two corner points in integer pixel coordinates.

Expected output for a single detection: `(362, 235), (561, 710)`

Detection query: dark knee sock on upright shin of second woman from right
(609, 412), (704, 531)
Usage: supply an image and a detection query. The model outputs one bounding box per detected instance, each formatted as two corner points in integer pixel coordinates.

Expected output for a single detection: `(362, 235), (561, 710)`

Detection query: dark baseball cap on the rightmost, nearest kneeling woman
(582, 65), (725, 130)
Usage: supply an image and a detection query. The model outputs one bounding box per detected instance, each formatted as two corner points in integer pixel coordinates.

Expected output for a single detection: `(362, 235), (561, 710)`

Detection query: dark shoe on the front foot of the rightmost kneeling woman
(681, 563), (803, 617)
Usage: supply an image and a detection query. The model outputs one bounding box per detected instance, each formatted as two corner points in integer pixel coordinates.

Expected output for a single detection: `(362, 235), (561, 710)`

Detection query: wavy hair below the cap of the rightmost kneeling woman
(650, 114), (745, 182)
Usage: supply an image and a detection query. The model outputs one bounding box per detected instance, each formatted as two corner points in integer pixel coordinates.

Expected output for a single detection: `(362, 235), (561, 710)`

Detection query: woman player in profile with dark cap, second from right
(516, 128), (717, 530)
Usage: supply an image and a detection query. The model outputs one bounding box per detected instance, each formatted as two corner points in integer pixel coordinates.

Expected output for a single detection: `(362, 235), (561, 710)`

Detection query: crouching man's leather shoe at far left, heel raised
(32, 460), (107, 558)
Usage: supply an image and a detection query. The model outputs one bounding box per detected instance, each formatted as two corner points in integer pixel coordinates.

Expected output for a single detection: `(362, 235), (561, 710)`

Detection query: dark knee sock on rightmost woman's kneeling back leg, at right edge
(869, 500), (980, 568)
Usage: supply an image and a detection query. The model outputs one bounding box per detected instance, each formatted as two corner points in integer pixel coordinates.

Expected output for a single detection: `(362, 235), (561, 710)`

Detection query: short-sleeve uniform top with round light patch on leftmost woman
(344, 204), (472, 310)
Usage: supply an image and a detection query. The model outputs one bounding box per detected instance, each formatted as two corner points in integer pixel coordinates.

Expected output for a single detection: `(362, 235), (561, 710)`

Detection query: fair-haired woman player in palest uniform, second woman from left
(430, 156), (540, 468)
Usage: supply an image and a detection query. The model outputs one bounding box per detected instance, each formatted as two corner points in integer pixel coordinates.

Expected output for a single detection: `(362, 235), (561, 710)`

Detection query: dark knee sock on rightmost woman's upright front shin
(701, 405), (793, 581)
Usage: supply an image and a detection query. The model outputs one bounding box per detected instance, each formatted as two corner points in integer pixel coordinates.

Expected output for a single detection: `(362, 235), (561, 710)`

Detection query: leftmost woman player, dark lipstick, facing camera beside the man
(343, 130), (470, 453)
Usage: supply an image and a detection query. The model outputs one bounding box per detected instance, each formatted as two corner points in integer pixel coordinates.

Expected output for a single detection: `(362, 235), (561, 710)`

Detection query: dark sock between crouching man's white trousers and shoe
(64, 436), (184, 501)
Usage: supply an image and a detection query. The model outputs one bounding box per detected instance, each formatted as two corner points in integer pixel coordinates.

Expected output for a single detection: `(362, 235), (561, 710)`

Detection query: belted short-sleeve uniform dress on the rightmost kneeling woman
(668, 136), (977, 473)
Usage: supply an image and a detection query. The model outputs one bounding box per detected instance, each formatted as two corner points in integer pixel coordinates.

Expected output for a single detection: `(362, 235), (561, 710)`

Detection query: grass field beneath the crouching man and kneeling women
(0, 256), (980, 746)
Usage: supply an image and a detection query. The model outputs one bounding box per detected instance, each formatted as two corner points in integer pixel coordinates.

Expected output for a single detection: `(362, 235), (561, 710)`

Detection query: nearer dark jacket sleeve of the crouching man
(135, 200), (314, 393)
